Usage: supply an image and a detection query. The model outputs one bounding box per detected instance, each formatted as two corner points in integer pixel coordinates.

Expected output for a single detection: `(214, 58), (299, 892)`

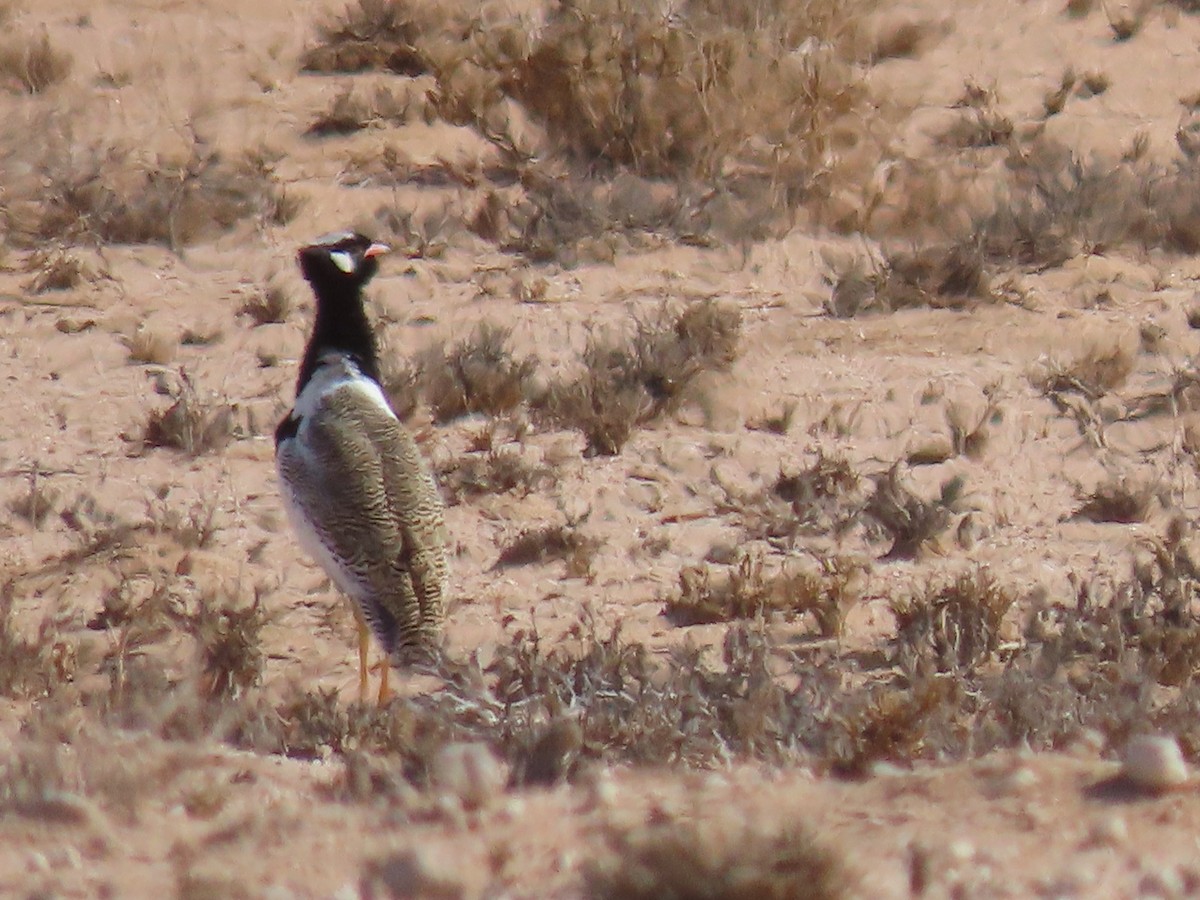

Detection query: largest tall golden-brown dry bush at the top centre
(475, 0), (865, 184)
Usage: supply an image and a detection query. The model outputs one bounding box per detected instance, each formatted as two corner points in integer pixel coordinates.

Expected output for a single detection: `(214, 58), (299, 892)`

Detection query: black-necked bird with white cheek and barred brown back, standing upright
(275, 232), (448, 704)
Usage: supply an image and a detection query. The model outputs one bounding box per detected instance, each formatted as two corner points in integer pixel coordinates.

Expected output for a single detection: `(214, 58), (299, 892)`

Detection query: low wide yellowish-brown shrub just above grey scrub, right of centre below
(662, 553), (863, 637)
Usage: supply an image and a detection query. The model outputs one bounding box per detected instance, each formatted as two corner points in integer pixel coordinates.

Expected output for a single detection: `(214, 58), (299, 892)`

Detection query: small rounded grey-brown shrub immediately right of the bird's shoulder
(420, 322), (538, 422)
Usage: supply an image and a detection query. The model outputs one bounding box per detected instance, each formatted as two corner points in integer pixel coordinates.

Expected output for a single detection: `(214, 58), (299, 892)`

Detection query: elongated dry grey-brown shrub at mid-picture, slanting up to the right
(545, 300), (742, 456)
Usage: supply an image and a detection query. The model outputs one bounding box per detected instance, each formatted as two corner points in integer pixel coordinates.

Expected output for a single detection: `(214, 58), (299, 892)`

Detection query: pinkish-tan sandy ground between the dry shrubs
(7, 0), (1200, 898)
